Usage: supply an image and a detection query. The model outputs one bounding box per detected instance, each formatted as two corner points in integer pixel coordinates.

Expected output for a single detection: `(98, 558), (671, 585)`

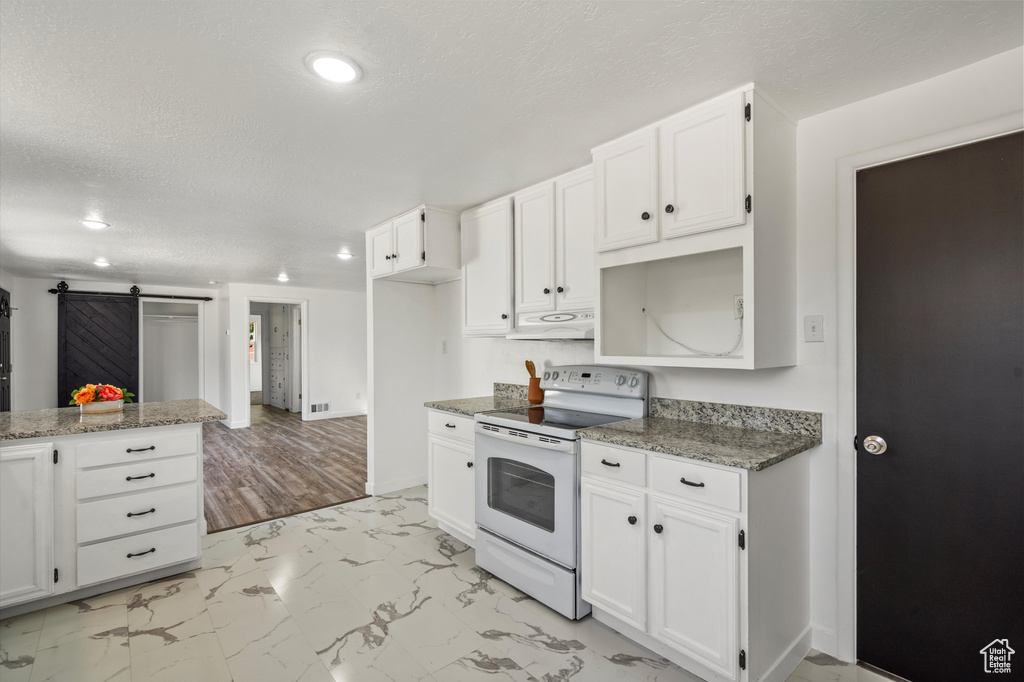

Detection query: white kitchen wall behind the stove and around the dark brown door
(419, 49), (1024, 657)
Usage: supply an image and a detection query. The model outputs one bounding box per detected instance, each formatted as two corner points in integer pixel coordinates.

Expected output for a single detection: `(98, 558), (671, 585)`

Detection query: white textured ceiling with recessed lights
(0, 0), (1024, 289)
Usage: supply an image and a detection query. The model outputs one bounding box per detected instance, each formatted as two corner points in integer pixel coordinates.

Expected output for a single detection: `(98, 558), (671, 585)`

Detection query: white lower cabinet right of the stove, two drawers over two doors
(581, 440), (810, 682)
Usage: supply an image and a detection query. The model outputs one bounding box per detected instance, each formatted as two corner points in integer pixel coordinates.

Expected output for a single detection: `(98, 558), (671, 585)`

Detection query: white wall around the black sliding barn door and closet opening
(0, 271), (223, 411)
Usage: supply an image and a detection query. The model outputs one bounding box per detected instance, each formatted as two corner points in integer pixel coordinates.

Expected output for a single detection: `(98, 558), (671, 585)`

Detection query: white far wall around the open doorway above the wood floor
(220, 284), (367, 428)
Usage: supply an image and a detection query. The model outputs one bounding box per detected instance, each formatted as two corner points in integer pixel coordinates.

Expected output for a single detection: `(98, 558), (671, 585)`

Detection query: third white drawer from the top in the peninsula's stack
(75, 485), (199, 544)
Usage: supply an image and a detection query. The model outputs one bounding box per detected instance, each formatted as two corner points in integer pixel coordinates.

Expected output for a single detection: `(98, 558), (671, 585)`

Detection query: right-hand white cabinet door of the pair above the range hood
(555, 166), (597, 310)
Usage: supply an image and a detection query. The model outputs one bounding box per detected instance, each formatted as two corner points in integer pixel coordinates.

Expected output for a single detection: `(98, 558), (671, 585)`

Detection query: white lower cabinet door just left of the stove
(427, 434), (476, 539)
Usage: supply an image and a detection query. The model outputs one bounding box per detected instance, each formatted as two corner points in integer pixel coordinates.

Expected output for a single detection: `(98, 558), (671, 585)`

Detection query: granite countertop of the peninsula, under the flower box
(0, 399), (227, 440)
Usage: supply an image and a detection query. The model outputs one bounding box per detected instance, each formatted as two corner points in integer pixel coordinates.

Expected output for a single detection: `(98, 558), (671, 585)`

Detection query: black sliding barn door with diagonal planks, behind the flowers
(57, 293), (138, 407)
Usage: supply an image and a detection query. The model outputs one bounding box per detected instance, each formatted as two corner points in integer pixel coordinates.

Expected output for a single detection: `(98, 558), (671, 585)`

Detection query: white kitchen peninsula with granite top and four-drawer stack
(0, 399), (226, 617)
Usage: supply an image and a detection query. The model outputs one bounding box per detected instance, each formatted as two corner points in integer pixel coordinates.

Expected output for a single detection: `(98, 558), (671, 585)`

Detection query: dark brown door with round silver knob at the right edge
(857, 133), (1024, 682)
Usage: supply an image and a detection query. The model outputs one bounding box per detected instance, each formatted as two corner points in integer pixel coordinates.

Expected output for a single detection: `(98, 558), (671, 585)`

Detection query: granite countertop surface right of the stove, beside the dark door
(580, 417), (821, 471)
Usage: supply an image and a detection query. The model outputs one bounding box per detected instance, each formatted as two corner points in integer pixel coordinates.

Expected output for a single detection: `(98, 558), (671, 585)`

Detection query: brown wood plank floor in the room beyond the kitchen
(203, 404), (367, 532)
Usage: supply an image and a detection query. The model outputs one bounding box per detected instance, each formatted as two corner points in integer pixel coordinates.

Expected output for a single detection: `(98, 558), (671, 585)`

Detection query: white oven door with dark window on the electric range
(476, 424), (580, 568)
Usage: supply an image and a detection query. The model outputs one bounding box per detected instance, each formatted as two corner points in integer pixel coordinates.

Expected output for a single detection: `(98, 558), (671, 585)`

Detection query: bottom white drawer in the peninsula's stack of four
(78, 523), (199, 587)
